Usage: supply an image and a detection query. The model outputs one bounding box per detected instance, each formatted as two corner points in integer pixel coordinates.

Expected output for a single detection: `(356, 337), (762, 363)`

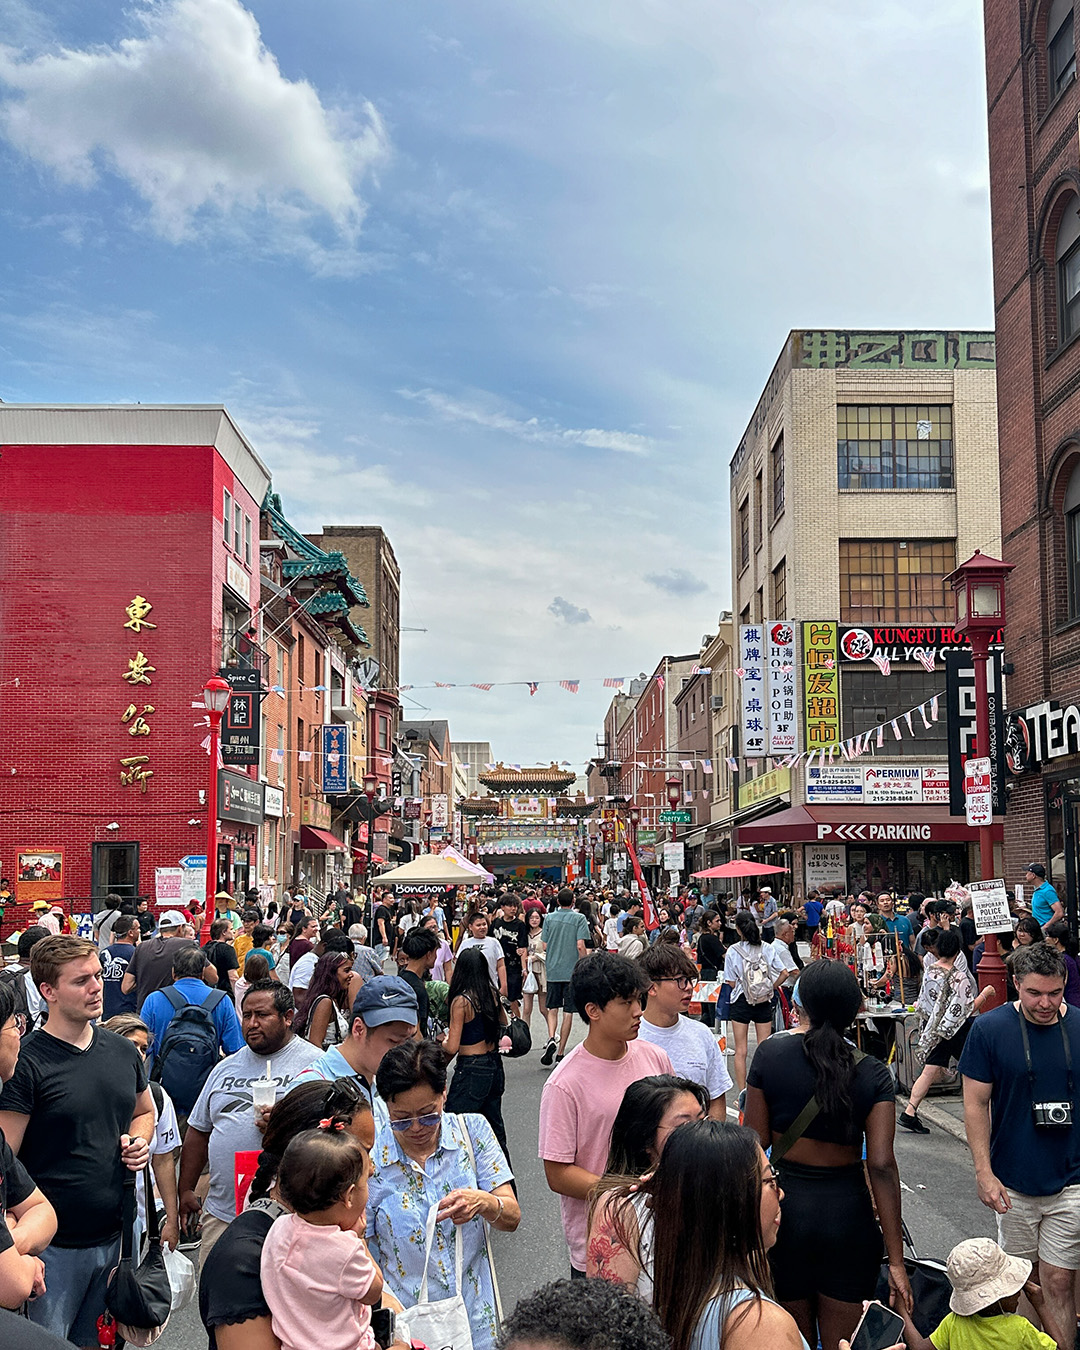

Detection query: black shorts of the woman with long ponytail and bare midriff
(770, 1161), (884, 1303)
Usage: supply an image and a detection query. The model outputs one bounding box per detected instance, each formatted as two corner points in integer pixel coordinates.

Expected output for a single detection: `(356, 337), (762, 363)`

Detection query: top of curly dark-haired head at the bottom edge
(498, 1280), (671, 1350)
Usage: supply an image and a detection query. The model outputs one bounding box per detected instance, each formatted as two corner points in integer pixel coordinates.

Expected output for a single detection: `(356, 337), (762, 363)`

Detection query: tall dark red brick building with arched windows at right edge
(986, 0), (1080, 914)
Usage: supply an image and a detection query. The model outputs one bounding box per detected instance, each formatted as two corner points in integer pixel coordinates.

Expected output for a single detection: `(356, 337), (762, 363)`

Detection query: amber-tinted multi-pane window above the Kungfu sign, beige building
(840, 539), (956, 621)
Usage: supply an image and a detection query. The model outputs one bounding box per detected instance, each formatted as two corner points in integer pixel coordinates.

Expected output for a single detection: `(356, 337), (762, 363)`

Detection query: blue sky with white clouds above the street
(0, 0), (992, 767)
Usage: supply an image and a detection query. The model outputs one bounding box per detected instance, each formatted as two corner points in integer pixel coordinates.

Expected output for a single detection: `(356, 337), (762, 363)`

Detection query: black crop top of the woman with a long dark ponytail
(747, 1031), (896, 1145)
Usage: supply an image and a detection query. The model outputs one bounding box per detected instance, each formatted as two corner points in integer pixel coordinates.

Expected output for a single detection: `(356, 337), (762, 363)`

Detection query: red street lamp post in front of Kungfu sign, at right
(945, 548), (1014, 1007)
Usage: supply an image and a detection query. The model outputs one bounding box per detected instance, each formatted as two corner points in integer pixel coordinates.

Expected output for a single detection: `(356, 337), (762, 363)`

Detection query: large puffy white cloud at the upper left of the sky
(0, 0), (387, 251)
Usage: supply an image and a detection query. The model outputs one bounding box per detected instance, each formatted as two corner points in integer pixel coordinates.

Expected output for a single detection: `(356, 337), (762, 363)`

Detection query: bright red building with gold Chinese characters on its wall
(0, 404), (270, 926)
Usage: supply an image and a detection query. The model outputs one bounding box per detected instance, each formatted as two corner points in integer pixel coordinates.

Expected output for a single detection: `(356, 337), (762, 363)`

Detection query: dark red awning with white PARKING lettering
(738, 805), (1003, 846)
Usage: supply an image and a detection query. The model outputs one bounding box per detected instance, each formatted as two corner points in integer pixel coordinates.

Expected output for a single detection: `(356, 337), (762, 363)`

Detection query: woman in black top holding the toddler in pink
(198, 1079), (394, 1350)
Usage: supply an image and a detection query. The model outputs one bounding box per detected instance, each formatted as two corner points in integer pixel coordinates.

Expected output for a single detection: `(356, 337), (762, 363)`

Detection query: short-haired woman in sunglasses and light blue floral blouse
(366, 1041), (521, 1350)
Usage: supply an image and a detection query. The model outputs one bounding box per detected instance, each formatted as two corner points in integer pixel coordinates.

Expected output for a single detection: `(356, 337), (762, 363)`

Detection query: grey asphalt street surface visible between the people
(158, 1018), (995, 1350)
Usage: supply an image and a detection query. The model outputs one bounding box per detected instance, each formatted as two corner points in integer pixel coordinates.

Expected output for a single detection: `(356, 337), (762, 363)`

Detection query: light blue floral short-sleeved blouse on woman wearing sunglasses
(365, 1111), (513, 1350)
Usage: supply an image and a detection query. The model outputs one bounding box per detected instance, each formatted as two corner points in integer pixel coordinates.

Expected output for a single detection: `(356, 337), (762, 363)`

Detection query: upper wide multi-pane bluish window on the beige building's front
(836, 404), (956, 490)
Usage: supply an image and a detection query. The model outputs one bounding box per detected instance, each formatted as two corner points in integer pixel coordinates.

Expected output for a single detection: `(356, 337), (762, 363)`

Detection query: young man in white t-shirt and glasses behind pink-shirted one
(637, 942), (732, 1121)
